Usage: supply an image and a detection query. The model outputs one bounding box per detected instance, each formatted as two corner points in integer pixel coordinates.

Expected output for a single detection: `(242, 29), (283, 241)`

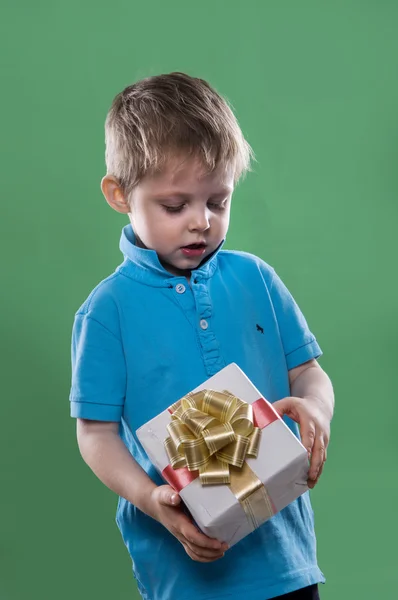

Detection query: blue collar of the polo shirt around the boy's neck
(119, 224), (225, 287)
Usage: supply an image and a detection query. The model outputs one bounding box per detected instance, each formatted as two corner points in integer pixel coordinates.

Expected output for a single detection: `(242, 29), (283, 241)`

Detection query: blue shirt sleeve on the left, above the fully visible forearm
(69, 313), (126, 421)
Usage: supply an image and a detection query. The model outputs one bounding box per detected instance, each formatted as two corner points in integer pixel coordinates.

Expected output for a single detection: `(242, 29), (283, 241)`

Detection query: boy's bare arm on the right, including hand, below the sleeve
(273, 359), (334, 488)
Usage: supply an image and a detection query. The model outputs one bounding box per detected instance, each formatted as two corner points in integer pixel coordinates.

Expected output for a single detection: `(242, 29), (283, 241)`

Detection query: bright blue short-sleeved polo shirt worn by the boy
(70, 225), (324, 600)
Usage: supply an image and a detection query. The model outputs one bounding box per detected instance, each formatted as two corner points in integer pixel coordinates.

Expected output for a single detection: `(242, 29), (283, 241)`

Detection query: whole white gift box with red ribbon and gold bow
(136, 363), (309, 546)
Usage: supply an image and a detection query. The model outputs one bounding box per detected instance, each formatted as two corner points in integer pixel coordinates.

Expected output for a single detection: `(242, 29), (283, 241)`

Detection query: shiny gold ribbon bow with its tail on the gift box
(165, 390), (273, 529)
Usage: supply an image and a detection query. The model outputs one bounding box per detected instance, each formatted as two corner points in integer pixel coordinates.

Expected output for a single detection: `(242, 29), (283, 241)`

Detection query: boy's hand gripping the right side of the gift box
(272, 396), (330, 489)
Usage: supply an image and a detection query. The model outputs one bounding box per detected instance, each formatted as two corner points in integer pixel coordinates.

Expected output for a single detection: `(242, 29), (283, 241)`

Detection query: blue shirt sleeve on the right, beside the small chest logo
(269, 269), (322, 370)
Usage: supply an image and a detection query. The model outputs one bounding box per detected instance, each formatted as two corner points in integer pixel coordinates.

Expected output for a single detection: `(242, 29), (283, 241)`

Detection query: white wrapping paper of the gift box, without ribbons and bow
(137, 363), (309, 546)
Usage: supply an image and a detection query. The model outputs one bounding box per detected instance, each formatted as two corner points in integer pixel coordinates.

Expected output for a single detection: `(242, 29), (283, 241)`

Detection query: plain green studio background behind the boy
(0, 0), (398, 600)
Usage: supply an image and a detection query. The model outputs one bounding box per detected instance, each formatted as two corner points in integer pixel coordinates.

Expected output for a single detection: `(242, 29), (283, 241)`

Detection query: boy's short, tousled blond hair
(105, 73), (254, 194)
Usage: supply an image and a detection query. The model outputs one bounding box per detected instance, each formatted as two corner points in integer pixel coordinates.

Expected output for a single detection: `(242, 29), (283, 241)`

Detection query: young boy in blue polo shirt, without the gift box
(70, 73), (334, 600)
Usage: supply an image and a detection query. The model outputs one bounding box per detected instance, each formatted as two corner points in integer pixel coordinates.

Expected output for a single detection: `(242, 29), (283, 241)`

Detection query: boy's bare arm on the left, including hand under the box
(77, 419), (227, 562)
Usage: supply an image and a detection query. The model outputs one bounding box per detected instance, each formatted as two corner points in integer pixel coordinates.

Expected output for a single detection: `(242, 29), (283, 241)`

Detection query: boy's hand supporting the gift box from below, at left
(151, 485), (228, 562)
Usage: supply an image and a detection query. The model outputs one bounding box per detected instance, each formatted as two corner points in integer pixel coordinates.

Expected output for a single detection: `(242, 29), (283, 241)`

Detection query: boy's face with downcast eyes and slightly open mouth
(129, 158), (234, 277)
